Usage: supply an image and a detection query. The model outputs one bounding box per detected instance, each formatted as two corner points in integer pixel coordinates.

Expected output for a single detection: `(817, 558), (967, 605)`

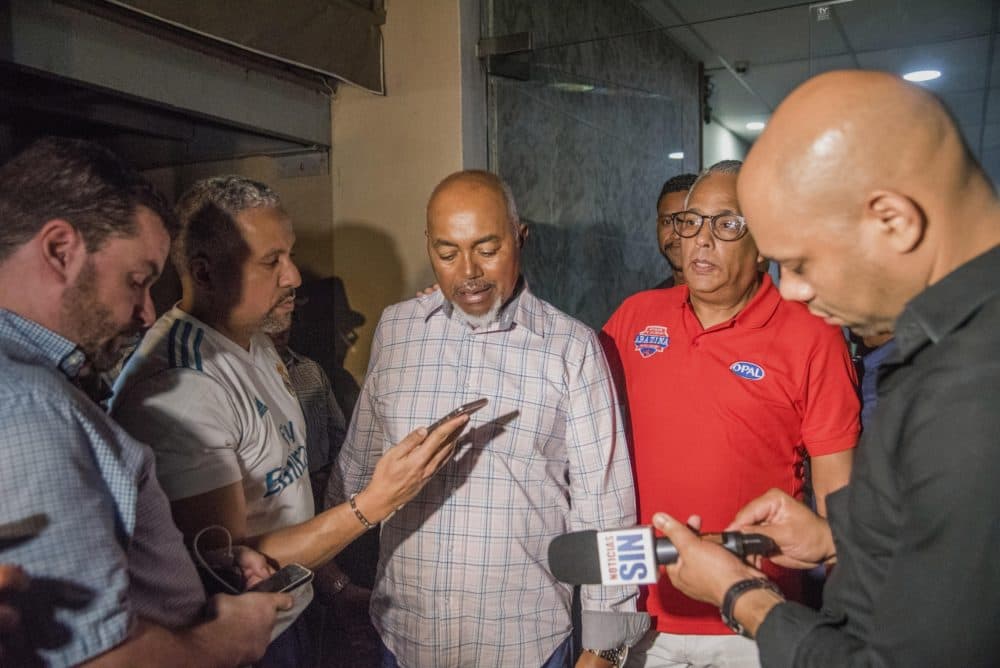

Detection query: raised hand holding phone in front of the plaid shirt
(356, 415), (469, 524)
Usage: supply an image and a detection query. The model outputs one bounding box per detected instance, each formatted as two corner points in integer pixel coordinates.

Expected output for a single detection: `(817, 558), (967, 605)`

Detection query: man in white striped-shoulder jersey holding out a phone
(112, 176), (467, 665)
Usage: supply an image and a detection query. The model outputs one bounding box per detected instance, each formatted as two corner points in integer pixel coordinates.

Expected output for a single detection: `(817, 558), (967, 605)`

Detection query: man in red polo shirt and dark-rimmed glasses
(602, 161), (859, 667)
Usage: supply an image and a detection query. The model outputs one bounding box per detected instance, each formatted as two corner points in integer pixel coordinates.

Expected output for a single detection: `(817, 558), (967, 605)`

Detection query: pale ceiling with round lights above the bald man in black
(632, 0), (1000, 183)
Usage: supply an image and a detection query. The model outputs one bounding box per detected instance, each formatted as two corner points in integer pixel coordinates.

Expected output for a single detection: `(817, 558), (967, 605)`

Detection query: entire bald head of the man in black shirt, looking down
(738, 71), (1000, 335)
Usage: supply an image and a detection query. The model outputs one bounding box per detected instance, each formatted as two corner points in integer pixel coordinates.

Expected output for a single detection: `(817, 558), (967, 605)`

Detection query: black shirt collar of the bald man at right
(894, 246), (1000, 360)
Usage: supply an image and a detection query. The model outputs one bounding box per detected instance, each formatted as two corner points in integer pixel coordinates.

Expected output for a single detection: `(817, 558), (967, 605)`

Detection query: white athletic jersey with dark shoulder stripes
(111, 306), (313, 536)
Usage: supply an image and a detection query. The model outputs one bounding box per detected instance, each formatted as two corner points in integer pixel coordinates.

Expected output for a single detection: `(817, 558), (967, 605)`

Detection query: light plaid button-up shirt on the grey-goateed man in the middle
(329, 286), (648, 668)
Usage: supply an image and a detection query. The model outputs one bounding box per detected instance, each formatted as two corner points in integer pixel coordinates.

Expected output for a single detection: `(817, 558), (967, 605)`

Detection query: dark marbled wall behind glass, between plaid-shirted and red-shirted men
(482, 0), (700, 327)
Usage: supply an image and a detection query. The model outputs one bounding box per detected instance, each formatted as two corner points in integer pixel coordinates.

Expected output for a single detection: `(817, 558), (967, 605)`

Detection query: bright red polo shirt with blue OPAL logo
(602, 275), (859, 634)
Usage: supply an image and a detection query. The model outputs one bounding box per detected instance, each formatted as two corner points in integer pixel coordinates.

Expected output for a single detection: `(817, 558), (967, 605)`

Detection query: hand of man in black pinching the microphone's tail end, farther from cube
(726, 489), (837, 569)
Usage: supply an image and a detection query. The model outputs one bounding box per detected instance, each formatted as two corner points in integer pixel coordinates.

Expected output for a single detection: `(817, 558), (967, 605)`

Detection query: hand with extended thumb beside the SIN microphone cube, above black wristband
(653, 513), (764, 607)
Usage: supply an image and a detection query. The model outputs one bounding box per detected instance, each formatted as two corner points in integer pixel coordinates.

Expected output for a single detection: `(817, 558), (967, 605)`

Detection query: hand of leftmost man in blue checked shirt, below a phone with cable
(191, 592), (294, 666)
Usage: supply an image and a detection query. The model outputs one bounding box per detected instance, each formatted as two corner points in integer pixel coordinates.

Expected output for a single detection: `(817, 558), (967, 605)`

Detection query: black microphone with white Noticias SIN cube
(549, 526), (778, 585)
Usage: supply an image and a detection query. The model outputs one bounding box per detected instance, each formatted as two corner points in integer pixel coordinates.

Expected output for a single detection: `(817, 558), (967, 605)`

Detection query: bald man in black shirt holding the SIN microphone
(656, 71), (1000, 667)
